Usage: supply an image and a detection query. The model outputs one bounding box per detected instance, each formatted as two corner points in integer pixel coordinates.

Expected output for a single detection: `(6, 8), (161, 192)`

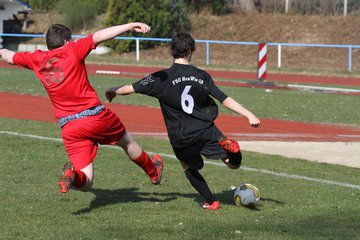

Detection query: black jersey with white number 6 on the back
(133, 63), (227, 147)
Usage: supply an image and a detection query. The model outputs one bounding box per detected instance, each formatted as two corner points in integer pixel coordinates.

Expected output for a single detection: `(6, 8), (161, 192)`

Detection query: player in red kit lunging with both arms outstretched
(0, 22), (163, 193)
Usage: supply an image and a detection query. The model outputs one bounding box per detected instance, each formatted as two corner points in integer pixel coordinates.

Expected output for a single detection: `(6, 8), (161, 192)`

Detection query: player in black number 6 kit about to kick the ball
(105, 33), (260, 210)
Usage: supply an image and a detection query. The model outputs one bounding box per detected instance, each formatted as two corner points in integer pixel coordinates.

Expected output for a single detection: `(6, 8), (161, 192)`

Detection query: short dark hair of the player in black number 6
(170, 33), (195, 58)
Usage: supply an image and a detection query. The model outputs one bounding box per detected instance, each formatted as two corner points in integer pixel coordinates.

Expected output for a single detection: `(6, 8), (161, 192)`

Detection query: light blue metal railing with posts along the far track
(0, 33), (360, 72)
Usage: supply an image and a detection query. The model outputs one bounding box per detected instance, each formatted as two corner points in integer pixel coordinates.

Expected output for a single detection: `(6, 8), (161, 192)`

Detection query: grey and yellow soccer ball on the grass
(234, 183), (260, 208)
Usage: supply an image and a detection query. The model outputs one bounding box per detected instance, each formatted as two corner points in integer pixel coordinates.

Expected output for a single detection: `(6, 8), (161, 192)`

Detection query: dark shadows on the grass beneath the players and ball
(73, 188), (284, 215)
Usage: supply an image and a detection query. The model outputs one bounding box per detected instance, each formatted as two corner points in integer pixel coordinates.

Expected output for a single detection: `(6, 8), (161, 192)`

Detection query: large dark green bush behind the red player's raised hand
(105, 0), (191, 52)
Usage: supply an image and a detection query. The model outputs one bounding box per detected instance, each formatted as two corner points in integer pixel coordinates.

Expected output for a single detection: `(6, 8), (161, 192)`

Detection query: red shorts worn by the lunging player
(61, 108), (125, 169)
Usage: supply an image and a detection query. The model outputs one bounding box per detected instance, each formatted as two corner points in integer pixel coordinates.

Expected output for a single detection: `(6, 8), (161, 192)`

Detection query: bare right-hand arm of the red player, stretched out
(93, 22), (151, 45)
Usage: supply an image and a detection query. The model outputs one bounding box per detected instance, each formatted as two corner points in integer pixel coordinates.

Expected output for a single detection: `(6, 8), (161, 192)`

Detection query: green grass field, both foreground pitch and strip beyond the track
(0, 69), (360, 240)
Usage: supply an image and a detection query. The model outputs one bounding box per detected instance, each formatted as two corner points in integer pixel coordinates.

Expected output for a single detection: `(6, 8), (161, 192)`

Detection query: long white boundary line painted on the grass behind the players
(0, 131), (360, 190)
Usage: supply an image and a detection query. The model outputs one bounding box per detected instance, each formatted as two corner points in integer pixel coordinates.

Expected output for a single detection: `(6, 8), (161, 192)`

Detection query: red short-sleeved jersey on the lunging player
(13, 35), (100, 118)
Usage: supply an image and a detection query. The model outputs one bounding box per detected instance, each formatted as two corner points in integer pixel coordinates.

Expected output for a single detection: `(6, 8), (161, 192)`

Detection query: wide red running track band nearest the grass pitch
(0, 92), (360, 142)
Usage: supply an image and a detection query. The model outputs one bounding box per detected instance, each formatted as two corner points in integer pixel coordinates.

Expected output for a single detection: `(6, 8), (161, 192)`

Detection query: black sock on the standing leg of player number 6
(185, 168), (216, 204)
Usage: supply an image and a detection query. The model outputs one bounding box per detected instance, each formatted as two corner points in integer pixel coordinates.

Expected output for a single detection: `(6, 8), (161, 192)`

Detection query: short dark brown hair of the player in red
(46, 24), (72, 50)
